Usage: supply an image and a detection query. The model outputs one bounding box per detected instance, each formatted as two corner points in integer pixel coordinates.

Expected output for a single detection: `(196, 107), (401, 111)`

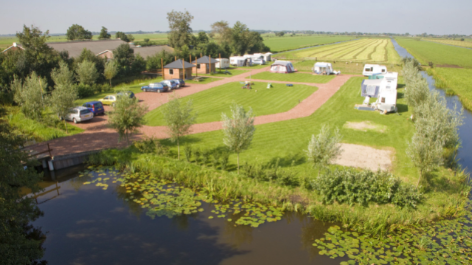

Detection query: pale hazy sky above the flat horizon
(0, 0), (472, 35)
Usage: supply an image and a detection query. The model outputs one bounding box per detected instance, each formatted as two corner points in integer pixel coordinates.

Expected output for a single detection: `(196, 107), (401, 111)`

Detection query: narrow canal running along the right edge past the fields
(392, 39), (472, 172)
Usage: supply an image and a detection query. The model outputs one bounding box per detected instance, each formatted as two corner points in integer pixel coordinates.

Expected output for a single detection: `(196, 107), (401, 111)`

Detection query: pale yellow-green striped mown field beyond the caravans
(277, 39), (401, 63)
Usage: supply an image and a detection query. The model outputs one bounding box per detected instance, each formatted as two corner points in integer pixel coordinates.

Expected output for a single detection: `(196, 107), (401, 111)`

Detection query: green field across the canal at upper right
(396, 38), (472, 68)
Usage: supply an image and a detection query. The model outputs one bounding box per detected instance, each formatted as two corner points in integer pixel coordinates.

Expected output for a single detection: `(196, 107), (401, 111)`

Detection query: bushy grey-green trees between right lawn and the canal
(403, 59), (463, 186)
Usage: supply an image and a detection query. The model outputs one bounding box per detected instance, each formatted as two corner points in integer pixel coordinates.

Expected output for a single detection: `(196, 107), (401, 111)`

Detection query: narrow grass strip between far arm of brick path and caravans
(251, 72), (334, 84)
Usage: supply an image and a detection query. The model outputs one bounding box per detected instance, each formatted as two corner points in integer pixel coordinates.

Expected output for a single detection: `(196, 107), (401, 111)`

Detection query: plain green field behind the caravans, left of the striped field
(264, 35), (354, 52)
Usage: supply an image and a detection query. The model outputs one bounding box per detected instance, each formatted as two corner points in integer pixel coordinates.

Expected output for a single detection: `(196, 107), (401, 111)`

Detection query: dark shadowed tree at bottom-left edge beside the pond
(0, 106), (45, 265)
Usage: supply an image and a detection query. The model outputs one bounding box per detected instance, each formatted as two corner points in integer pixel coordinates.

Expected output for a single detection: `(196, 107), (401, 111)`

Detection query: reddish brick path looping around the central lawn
(30, 67), (351, 156)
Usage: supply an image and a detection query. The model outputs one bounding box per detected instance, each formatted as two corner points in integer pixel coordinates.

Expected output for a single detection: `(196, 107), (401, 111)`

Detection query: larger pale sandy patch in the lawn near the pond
(333, 144), (392, 171)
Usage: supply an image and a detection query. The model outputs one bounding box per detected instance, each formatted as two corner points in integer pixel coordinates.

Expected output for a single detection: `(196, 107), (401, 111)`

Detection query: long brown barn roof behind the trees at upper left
(48, 39), (127, 57)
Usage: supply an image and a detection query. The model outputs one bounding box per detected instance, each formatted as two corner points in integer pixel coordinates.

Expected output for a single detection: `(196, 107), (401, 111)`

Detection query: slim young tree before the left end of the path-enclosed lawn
(162, 94), (196, 159)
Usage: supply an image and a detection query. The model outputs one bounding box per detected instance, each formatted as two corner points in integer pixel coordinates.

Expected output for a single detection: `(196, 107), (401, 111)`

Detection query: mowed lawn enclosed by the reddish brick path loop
(145, 82), (317, 126)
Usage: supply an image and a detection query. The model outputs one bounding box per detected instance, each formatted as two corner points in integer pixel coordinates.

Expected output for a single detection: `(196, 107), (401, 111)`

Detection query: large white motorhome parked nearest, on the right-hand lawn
(361, 72), (398, 113)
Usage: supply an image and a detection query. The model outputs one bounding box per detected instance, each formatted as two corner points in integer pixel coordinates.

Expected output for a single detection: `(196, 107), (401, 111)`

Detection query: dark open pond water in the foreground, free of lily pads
(35, 167), (343, 264)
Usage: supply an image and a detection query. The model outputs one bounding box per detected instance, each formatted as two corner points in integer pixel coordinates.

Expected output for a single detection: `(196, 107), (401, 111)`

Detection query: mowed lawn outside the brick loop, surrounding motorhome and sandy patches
(170, 77), (418, 183)
